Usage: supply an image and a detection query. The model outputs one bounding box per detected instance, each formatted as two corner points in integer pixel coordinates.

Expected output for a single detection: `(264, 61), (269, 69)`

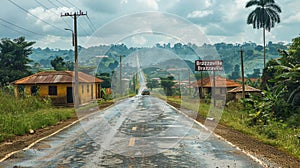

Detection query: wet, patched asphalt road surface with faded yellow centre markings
(0, 96), (262, 168)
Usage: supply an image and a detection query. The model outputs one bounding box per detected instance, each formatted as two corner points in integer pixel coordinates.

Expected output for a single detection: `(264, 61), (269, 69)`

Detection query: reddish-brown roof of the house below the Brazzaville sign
(191, 76), (241, 88)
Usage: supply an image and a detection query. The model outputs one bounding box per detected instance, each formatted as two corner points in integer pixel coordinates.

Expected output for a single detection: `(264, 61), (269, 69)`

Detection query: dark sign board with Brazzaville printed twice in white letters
(195, 60), (223, 71)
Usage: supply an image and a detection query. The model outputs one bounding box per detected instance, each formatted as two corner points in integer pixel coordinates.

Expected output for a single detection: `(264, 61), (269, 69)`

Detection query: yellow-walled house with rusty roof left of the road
(12, 71), (103, 105)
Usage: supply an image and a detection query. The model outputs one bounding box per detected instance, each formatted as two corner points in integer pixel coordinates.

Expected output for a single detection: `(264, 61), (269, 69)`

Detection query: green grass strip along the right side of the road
(167, 97), (300, 159)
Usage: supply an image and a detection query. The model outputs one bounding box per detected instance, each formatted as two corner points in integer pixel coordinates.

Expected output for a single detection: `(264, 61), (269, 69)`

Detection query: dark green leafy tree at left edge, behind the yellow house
(0, 37), (35, 86)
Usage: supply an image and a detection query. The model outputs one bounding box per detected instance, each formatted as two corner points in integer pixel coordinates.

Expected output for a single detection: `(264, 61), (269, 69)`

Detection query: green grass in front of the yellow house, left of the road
(0, 91), (75, 142)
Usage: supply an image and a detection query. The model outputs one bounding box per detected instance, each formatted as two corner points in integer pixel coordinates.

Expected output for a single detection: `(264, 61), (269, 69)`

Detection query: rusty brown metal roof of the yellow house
(13, 71), (103, 85)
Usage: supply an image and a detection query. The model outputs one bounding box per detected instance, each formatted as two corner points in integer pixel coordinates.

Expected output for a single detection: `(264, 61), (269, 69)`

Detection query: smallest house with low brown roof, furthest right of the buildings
(228, 85), (261, 100)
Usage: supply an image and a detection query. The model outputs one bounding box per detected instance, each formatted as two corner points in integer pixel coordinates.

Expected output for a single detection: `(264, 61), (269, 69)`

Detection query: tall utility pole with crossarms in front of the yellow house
(61, 10), (87, 108)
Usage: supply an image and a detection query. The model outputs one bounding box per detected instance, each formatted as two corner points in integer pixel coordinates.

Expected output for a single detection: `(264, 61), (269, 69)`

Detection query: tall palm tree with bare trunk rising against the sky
(246, 0), (281, 67)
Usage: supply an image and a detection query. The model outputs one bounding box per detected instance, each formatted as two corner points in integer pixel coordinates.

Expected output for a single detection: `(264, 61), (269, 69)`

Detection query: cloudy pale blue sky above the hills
(0, 0), (300, 49)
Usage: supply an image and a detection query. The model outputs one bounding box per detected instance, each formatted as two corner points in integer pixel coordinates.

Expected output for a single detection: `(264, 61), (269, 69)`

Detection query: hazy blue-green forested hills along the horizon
(30, 42), (287, 78)
